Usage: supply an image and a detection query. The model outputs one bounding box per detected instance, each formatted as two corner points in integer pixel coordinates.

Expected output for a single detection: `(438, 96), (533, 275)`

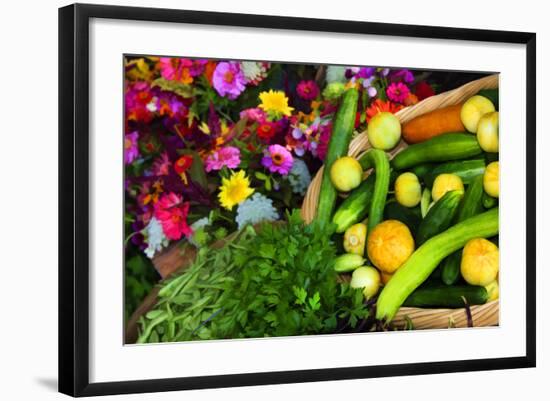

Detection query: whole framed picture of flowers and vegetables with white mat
(59, 4), (536, 396)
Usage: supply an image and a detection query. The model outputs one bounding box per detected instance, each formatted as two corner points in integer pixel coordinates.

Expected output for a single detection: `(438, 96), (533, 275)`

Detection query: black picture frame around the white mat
(59, 4), (536, 396)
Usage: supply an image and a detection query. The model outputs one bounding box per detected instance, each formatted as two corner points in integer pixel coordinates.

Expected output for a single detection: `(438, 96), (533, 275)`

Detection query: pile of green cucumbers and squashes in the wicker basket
(316, 88), (499, 321)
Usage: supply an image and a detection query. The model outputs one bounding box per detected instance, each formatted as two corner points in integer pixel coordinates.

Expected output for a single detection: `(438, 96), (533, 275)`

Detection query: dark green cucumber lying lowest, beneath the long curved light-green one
(403, 285), (489, 308)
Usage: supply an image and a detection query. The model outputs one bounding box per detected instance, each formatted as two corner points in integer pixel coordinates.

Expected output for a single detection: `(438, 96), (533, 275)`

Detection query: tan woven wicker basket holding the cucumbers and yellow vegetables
(302, 75), (499, 329)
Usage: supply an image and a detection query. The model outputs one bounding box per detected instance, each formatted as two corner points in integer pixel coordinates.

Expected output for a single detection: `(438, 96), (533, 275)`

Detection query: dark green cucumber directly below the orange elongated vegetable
(392, 133), (482, 170)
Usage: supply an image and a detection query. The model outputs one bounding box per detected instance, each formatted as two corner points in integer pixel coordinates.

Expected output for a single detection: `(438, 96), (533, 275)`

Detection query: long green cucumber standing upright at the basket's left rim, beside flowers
(316, 88), (359, 223)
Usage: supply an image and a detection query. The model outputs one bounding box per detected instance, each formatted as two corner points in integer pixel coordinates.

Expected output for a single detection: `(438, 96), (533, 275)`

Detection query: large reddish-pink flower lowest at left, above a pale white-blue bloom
(155, 192), (193, 241)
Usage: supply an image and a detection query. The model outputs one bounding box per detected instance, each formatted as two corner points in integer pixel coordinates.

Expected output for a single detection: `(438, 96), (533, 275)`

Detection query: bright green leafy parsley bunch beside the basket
(212, 211), (366, 338)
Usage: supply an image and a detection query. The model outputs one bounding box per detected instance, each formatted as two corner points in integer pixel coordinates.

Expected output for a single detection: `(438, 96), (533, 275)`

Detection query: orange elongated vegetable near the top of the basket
(401, 103), (466, 143)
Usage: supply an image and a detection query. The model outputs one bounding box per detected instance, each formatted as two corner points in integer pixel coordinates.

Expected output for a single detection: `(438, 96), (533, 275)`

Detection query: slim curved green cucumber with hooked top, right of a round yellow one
(365, 149), (390, 238)
